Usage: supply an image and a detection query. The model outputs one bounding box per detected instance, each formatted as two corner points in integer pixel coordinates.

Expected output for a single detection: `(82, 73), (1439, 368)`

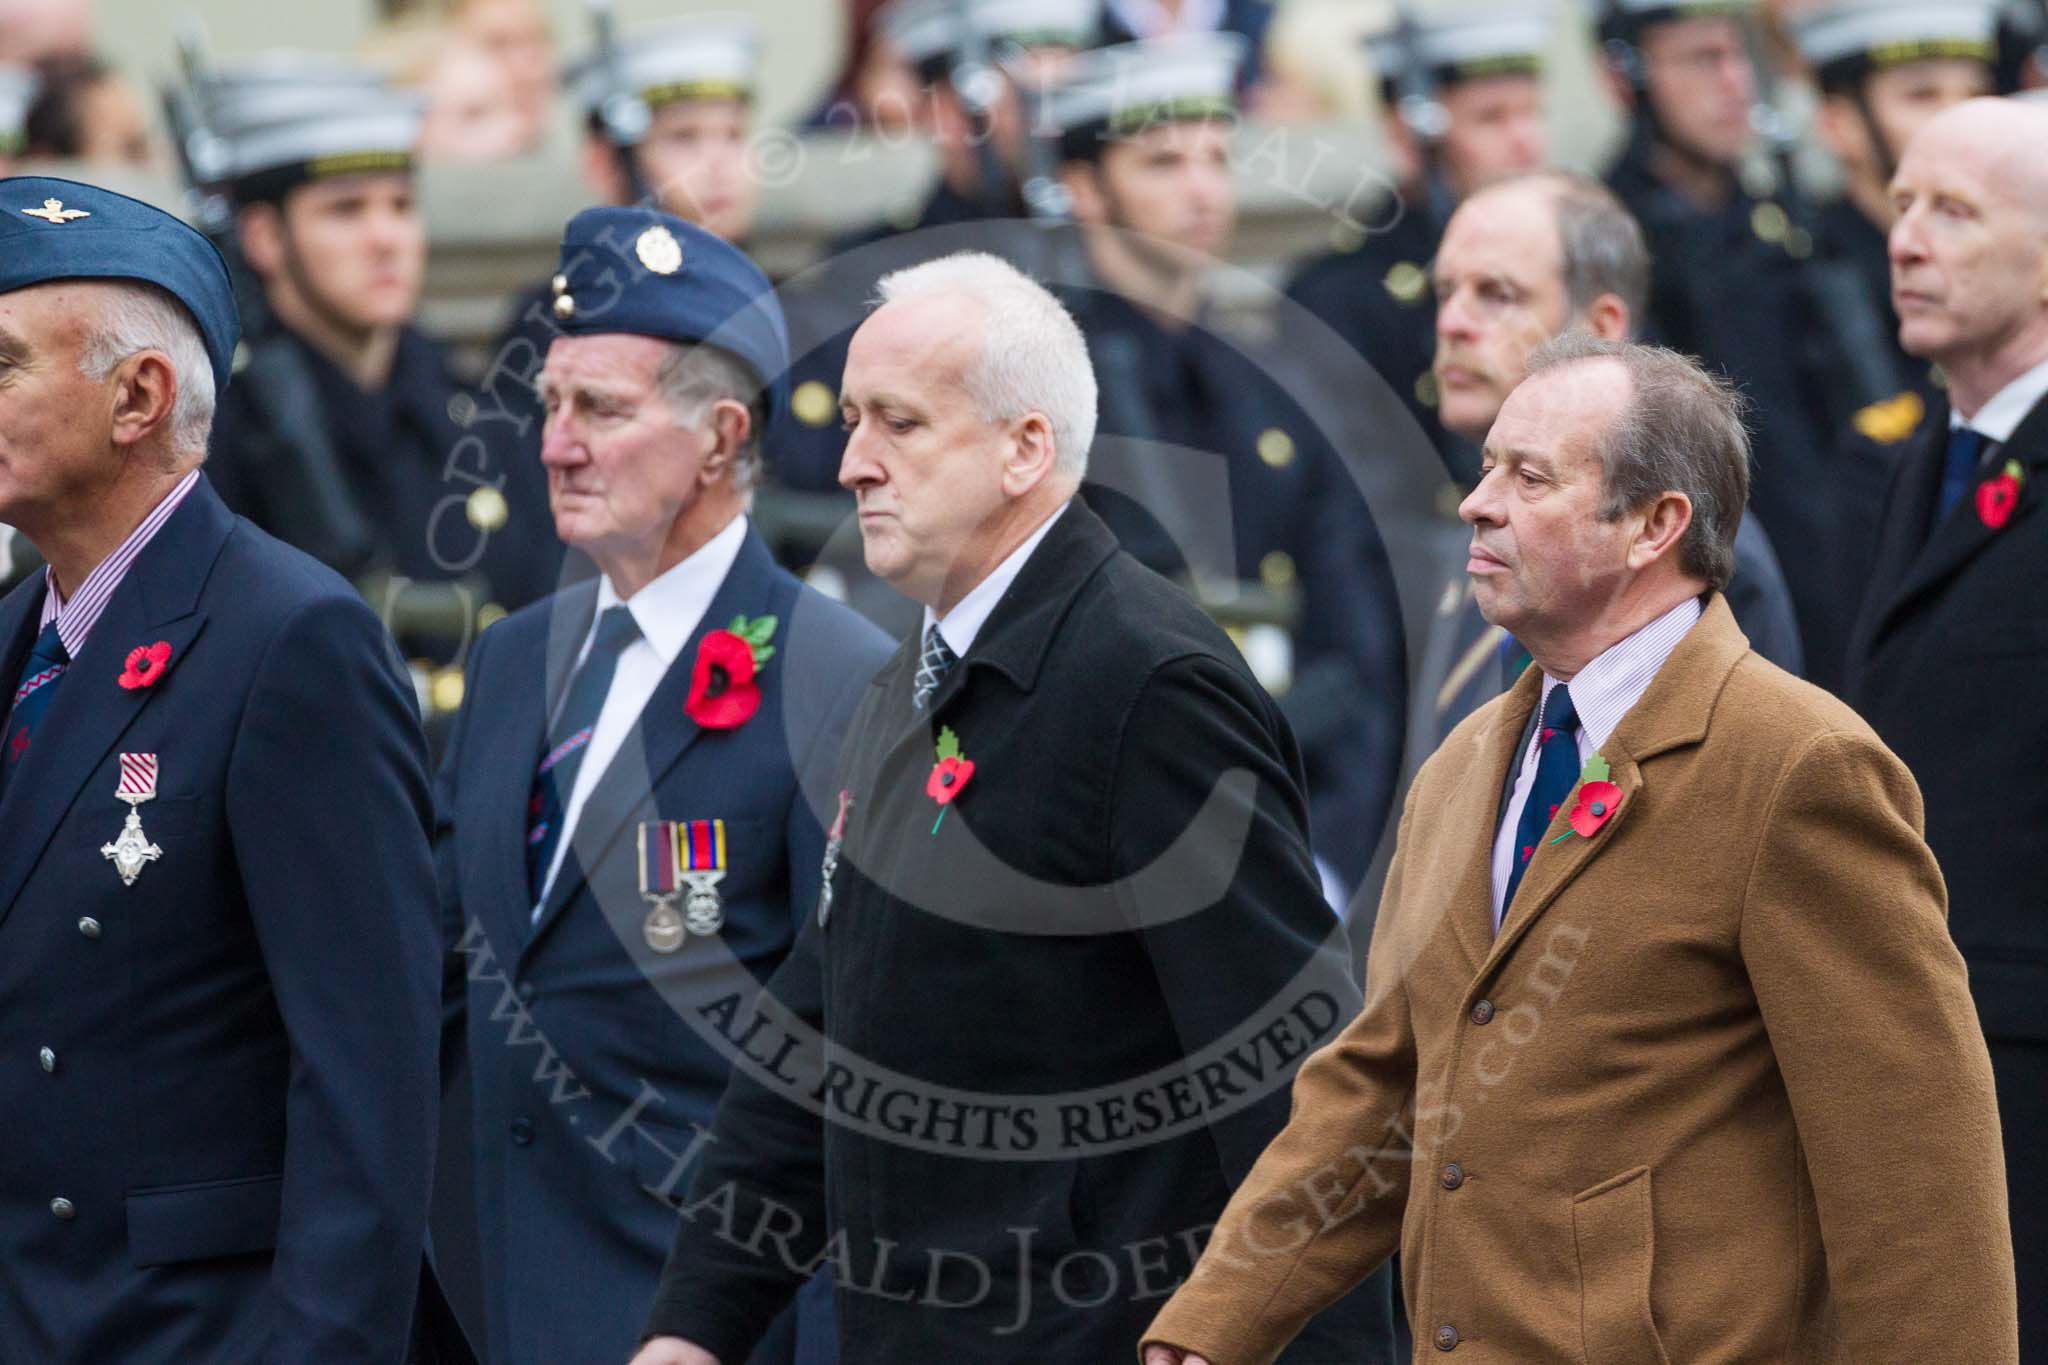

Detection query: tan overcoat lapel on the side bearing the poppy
(1481, 593), (1749, 978)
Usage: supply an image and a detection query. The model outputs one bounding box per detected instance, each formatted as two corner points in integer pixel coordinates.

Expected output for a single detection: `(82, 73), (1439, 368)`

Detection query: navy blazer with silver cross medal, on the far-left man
(0, 479), (436, 1365)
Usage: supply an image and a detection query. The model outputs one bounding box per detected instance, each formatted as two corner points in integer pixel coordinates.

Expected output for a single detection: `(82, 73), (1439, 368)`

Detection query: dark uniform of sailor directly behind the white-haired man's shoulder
(1065, 287), (1407, 888)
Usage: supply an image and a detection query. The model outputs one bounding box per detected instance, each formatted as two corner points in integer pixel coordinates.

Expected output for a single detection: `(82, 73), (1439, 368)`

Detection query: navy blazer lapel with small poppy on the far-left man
(0, 477), (233, 919)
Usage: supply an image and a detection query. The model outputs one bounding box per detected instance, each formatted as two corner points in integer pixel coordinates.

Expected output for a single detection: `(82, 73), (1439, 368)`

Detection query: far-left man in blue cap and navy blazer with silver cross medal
(0, 178), (436, 1365)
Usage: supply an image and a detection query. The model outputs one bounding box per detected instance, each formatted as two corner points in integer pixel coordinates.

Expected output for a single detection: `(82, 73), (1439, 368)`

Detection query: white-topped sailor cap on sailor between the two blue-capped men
(205, 53), (424, 203)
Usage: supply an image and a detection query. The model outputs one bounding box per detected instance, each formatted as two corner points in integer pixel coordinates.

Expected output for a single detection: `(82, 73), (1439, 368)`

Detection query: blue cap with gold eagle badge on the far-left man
(0, 176), (242, 393)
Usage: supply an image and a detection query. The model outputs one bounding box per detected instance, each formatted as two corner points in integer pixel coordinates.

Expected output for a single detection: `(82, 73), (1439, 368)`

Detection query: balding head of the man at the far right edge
(1890, 98), (2048, 415)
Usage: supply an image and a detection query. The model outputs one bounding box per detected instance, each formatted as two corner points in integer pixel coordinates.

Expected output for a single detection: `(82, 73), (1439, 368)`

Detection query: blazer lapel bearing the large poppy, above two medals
(520, 528), (791, 952)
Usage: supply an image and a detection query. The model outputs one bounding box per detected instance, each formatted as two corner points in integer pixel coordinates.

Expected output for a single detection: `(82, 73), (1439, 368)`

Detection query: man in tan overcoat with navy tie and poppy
(1141, 336), (2019, 1365)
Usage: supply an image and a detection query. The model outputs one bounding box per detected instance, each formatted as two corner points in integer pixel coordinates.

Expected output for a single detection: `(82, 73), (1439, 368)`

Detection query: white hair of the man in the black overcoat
(874, 252), (1096, 479)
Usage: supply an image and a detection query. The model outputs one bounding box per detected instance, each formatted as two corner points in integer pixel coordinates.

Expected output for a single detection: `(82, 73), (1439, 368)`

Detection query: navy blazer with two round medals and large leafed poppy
(436, 530), (891, 1365)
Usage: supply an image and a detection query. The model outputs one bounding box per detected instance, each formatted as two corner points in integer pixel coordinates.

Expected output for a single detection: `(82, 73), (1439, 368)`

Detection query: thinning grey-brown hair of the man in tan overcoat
(1530, 329), (1749, 589)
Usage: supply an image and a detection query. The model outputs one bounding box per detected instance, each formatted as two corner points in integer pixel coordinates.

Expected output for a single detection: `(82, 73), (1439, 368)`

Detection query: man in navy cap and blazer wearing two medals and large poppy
(436, 209), (891, 1365)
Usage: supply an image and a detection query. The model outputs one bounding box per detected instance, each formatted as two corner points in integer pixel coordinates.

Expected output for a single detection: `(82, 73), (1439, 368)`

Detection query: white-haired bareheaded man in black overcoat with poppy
(639, 254), (1389, 1365)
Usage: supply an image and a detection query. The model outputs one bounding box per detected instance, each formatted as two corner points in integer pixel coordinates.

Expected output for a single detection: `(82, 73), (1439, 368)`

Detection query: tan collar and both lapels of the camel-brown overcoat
(1448, 593), (1749, 988)
